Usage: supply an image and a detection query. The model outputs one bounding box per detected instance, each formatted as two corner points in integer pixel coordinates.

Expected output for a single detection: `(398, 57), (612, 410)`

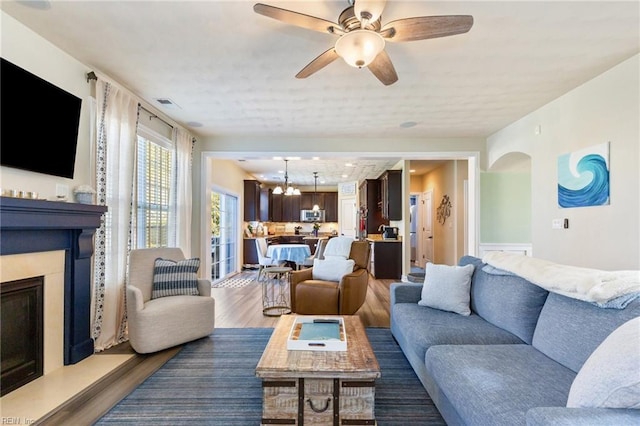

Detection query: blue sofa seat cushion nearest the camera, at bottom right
(425, 344), (576, 426)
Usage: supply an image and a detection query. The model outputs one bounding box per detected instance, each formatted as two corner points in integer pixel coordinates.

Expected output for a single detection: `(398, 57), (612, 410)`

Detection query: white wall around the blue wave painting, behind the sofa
(487, 55), (640, 269)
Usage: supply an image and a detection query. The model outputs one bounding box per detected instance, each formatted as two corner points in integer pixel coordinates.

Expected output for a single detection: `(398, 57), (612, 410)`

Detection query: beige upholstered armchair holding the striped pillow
(127, 248), (215, 353)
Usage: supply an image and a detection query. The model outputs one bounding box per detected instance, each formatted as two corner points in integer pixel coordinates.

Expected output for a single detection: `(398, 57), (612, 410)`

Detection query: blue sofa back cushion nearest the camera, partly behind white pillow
(532, 293), (640, 373)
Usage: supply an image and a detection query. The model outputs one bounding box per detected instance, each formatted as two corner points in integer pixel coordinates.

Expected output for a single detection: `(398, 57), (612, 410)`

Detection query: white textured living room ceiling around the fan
(0, 0), (640, 185)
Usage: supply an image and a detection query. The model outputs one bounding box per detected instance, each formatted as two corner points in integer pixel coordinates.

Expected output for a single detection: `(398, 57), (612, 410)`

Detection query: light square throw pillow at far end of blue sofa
(418, 262), (474, 316)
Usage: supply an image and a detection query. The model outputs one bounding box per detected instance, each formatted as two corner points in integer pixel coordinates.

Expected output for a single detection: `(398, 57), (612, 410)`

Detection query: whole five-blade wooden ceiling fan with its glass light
(253, 0), (473, 86)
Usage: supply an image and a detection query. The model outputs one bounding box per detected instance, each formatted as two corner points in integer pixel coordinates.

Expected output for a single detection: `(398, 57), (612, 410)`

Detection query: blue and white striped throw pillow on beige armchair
(151, 258), (200, 299)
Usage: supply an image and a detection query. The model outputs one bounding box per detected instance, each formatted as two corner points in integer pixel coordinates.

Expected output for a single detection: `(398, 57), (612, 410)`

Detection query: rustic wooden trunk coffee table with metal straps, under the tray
(256, 315), (380, 426)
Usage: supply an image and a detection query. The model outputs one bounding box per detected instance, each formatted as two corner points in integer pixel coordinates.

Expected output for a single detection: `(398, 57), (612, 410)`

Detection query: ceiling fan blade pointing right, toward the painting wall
(380, 15), (473, 41)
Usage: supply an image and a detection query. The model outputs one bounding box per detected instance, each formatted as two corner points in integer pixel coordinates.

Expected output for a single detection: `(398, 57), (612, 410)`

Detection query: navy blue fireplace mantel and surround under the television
(0, 197), (107, 365)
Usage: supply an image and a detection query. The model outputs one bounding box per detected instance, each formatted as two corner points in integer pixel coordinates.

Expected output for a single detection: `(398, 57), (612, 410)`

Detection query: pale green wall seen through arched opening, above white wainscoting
(480, 172), (531, 243)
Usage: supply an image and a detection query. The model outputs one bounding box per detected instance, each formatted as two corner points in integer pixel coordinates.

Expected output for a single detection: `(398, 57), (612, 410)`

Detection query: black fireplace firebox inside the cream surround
(0, 276), (44, 396)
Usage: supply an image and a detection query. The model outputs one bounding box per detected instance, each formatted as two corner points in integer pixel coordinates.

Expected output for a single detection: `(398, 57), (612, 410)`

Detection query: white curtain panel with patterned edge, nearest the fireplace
(92, 79), (138, 352)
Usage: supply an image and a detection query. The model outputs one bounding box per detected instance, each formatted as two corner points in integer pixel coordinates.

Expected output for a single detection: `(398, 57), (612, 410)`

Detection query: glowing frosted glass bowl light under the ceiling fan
(335, 30), (384, 68)
